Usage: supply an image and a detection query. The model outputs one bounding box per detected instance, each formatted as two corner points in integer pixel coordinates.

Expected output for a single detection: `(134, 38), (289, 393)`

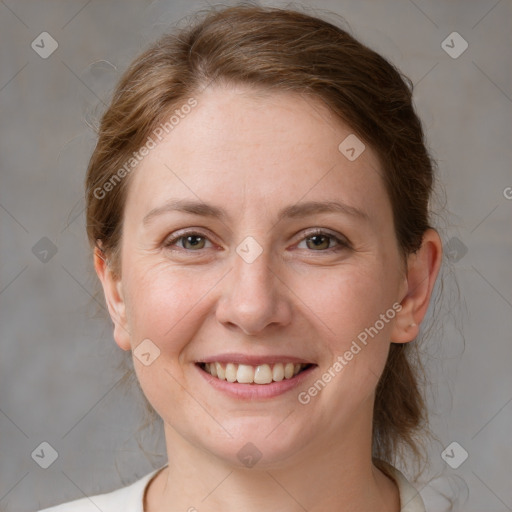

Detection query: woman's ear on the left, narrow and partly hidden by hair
(94, 247), (131, 350)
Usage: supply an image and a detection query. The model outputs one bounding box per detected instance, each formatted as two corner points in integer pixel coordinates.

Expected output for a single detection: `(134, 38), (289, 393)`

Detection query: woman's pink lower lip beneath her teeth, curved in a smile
(195, 365), (316, 400)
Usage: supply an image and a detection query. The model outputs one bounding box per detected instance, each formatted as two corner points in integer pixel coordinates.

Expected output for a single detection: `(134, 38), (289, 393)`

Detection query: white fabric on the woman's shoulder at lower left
(38, 466), (165, 512)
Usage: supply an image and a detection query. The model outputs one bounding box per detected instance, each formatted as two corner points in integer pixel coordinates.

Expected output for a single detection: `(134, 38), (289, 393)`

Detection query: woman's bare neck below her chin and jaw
(144, 402), (400, 512)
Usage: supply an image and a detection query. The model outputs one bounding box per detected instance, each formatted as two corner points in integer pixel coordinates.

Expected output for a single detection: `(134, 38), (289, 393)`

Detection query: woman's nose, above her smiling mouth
(216, 244), (292, 336)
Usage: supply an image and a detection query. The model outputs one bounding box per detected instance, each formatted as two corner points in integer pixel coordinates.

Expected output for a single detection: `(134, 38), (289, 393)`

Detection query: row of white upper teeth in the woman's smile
(204, 363), (307, 384)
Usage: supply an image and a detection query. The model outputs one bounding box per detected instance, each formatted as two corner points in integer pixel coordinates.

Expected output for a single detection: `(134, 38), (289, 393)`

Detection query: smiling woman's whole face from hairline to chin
(107, 87), (407, 467)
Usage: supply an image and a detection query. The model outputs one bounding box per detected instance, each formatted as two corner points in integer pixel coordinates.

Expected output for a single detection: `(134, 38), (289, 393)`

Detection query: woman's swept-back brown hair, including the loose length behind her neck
(86, 5), (434, 476)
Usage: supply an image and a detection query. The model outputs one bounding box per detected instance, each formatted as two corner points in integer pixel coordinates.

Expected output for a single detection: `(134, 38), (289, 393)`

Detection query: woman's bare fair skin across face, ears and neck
(95, 86), (441, 512)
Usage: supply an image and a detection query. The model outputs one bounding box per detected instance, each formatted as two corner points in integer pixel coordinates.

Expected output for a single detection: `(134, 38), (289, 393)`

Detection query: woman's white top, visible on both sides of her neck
(38, 464), (425, 512)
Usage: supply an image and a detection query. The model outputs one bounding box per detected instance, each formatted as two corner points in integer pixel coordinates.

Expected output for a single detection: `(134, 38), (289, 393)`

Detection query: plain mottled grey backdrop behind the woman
(0, 0), (512, 512)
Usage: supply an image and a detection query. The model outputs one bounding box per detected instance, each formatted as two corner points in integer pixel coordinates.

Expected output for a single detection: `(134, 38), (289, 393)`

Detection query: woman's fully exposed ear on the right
(391, 229), (442, 343)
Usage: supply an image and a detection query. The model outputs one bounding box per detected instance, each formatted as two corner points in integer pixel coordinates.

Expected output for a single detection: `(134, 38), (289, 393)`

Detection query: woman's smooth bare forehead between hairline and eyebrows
(126, 87), (390, 224)
